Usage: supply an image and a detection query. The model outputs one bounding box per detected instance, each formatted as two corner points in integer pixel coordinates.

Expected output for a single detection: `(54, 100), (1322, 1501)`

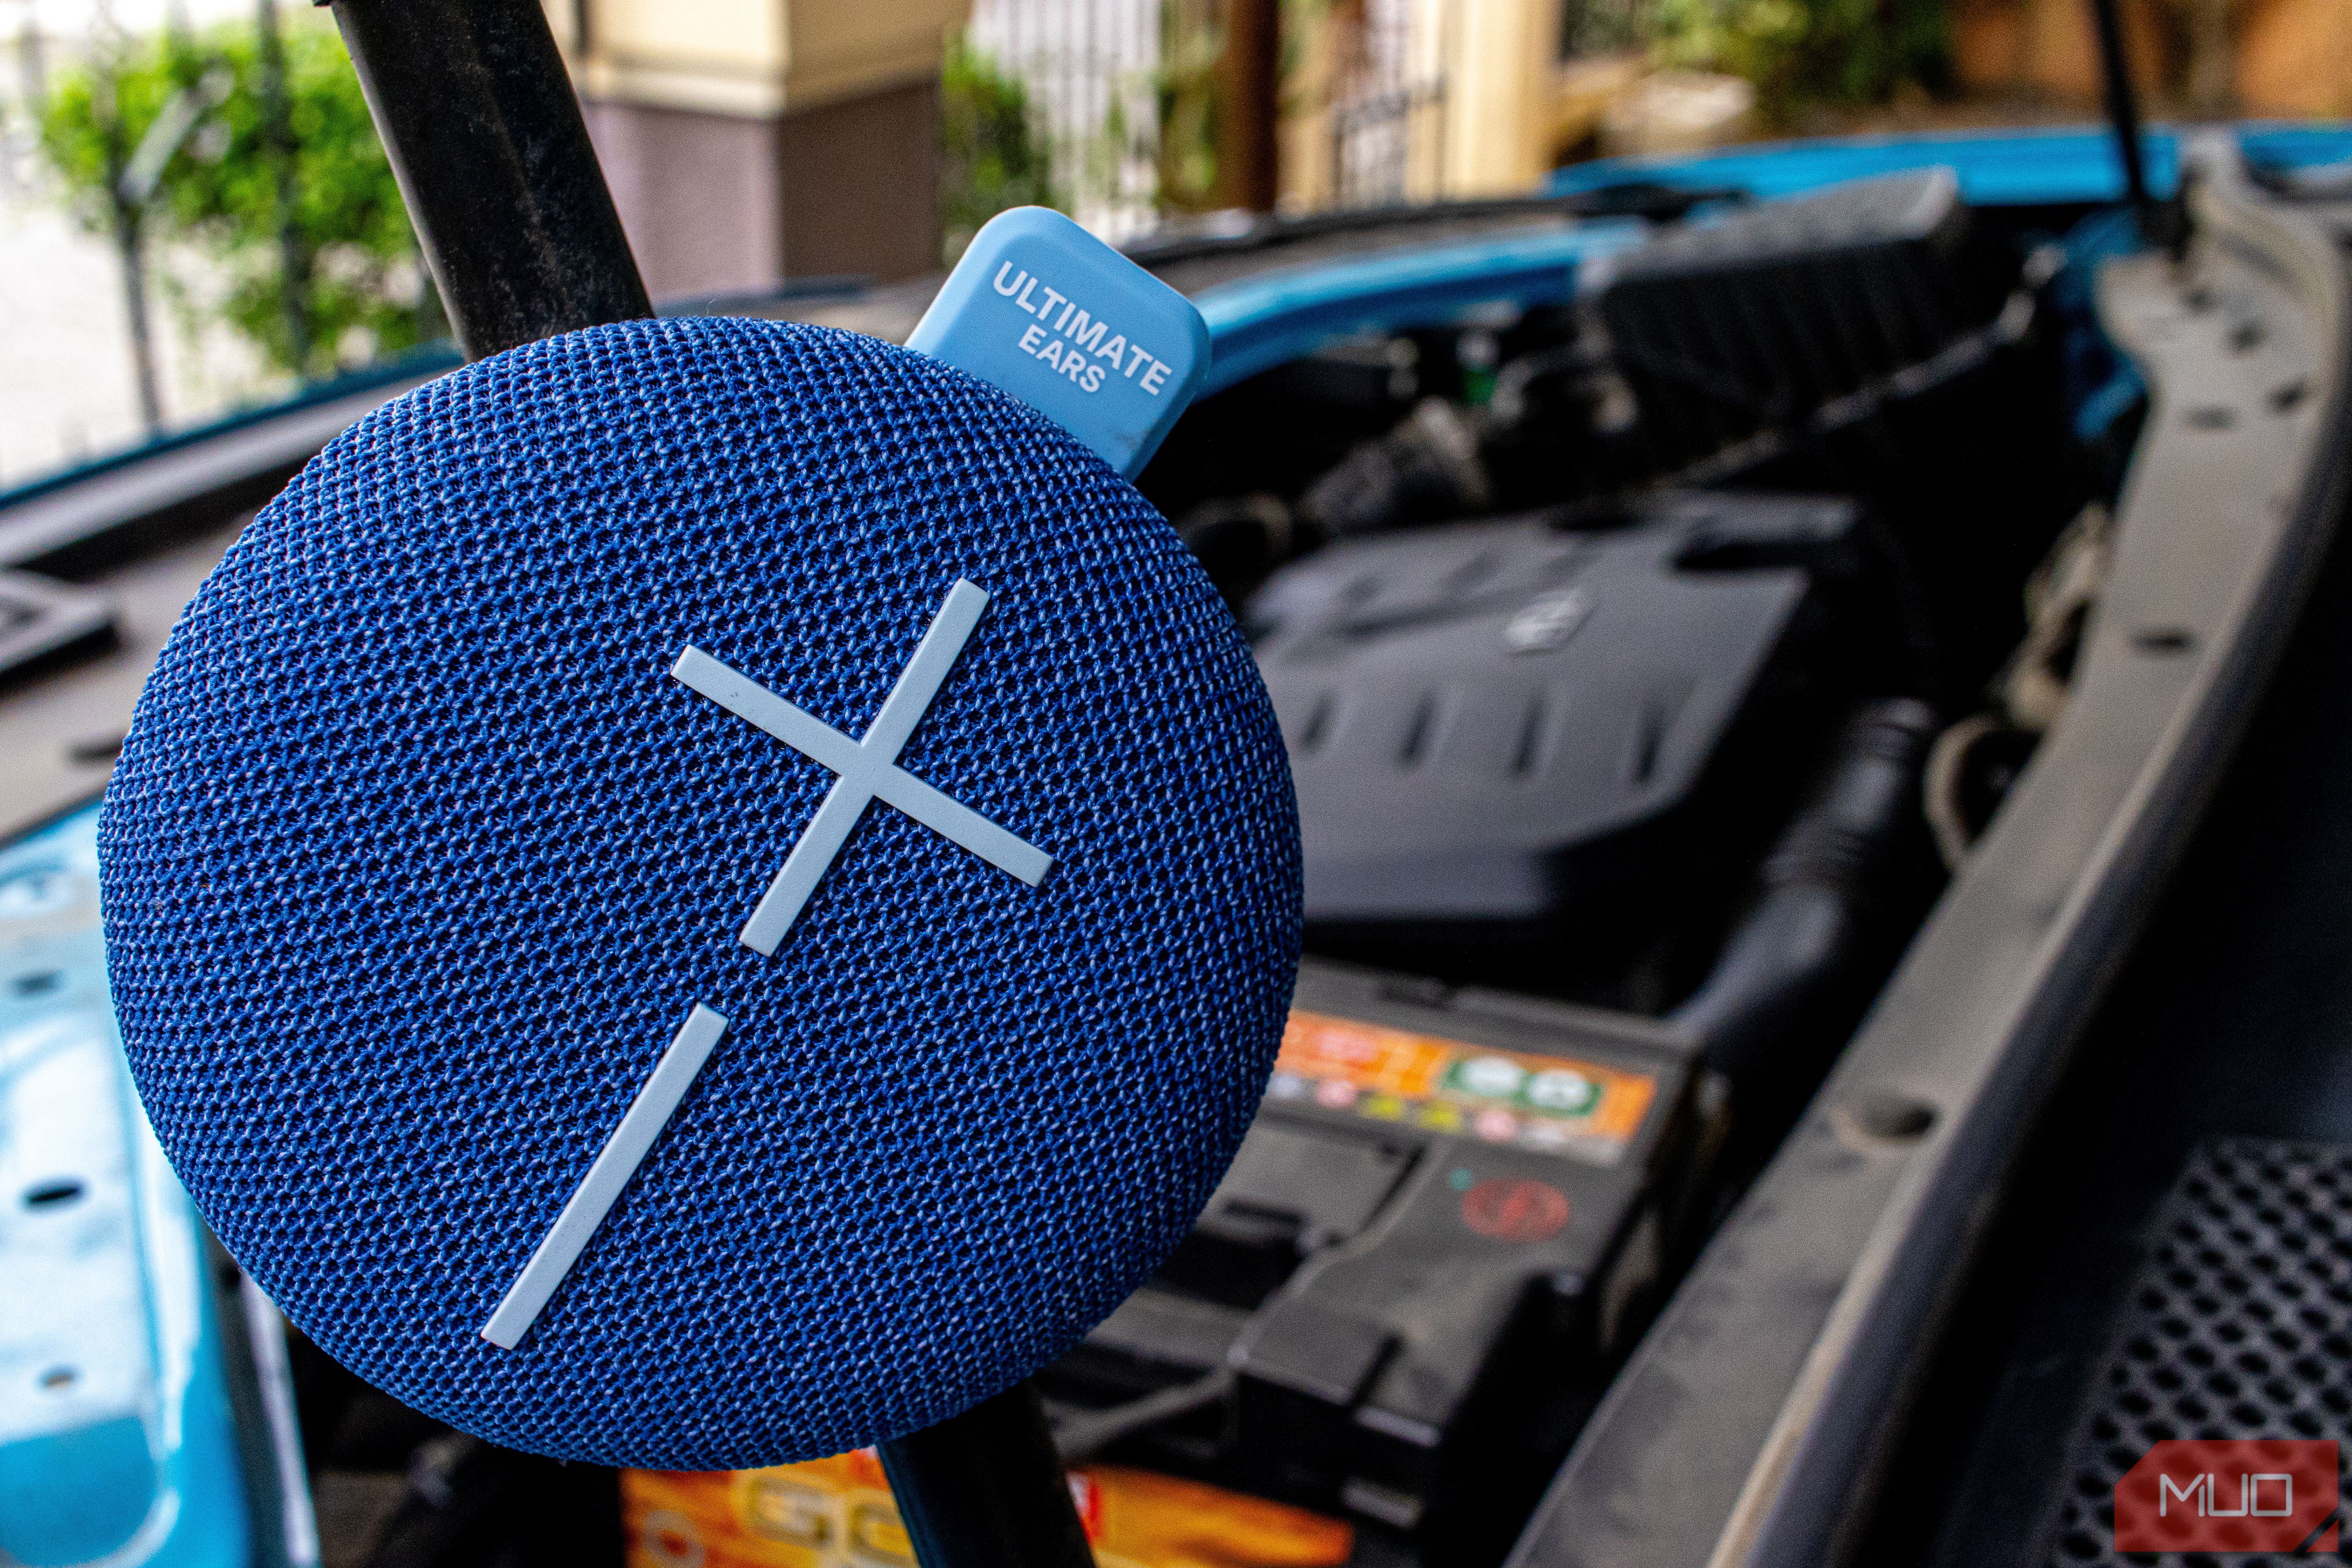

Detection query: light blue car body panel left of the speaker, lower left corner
(0, 806), (252, 1568)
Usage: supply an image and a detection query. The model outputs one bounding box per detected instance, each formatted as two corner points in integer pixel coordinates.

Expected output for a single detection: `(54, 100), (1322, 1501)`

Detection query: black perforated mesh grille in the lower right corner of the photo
(2046, 1138), (2352, 1568)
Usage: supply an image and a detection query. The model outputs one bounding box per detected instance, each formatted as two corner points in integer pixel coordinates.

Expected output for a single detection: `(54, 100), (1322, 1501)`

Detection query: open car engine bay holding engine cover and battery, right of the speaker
(1007, 169), (2140, 1566)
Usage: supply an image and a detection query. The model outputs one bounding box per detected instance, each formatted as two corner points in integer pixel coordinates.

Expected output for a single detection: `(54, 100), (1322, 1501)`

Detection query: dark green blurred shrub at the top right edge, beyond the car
(1656, 0), (1952, 120)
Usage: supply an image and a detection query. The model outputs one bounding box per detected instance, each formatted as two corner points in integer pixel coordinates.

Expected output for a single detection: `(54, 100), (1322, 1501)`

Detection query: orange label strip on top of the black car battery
(1268, 1011), (1658, 1164)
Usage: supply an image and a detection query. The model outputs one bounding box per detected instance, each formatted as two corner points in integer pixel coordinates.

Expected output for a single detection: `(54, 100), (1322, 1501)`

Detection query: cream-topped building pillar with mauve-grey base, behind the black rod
(546, 0), (969, 299)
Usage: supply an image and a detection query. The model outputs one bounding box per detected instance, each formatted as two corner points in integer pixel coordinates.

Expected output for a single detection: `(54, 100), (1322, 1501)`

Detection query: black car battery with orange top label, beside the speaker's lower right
(1042, 959), (1700, 1561)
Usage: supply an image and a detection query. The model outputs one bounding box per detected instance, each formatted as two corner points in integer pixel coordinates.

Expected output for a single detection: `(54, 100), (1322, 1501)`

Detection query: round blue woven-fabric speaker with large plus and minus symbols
(99, 320), (1298, 1469)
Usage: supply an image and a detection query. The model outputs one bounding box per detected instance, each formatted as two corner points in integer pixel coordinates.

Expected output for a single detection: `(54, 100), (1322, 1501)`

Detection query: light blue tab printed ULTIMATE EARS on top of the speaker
(906, 207), (1209, 479)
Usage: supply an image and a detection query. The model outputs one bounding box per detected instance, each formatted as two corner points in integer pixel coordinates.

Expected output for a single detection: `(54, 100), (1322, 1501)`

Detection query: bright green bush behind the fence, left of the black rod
(40, 7), (442, 376)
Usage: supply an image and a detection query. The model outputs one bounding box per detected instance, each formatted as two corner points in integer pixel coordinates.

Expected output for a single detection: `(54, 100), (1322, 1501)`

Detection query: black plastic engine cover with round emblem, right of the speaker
(1251, 494), (1856, 969)
